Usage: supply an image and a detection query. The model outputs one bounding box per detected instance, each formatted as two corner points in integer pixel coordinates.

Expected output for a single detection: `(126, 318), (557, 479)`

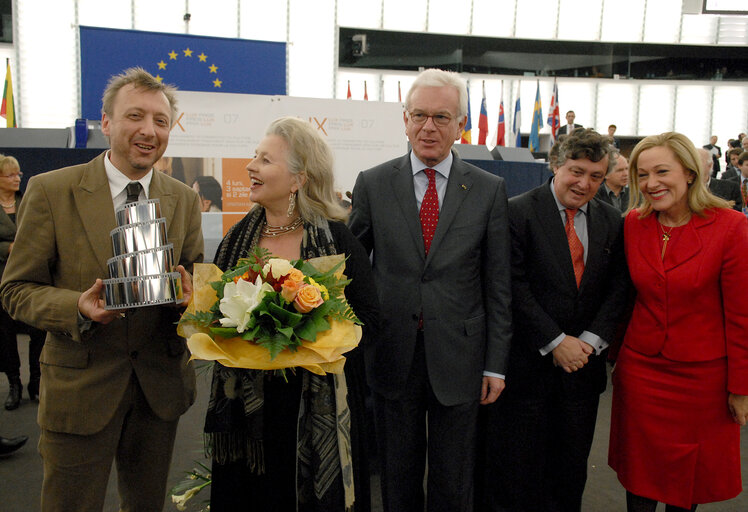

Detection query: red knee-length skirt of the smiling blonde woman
(608, 344), (742, 508)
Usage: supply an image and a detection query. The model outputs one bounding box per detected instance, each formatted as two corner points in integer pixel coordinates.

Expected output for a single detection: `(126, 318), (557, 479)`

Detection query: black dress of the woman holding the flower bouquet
(210, 218), (379, 512)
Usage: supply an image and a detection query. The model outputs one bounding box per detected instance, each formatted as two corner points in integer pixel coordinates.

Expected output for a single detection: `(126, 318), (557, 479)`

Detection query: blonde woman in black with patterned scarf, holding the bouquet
(205, 117), (379, 512)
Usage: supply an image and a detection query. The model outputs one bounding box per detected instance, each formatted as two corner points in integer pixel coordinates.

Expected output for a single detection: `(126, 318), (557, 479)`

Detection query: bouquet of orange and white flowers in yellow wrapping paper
(178, 248), (361, 374)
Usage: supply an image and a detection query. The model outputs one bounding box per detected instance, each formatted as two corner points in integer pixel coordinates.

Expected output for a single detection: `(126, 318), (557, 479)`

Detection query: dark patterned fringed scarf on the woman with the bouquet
(205, 206), (353, 506)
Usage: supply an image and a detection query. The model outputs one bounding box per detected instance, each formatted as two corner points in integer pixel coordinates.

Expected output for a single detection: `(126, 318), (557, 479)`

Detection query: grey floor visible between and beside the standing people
(0, 336), (748, 512)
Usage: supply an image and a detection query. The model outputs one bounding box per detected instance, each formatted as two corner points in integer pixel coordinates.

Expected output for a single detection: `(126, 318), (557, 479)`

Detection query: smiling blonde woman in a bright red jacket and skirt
(609, 132), (748, 512)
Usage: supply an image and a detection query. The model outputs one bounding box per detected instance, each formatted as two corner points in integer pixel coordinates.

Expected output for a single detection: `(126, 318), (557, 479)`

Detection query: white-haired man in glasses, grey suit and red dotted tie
(349, 69), (511, 512)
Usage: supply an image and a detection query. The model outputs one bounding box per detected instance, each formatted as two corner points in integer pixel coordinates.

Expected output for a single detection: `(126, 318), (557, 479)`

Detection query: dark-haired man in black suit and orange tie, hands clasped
(482, 129), (627, 512)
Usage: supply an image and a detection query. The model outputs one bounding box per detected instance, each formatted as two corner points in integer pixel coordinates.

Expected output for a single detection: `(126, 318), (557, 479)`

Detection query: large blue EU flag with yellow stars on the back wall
(80, 26), (286, 119)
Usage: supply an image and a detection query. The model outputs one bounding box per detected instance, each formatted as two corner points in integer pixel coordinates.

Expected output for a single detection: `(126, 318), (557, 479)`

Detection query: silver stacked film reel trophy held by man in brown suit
(104, 199), (182, 309)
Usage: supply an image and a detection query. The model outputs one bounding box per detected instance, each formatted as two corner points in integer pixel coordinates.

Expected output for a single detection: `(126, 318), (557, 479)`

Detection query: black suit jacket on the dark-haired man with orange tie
(507, 183), (628, 396)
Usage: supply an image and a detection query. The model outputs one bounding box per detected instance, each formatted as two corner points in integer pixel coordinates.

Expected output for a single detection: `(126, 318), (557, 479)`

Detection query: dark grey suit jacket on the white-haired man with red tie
(349, 152), (511, 406)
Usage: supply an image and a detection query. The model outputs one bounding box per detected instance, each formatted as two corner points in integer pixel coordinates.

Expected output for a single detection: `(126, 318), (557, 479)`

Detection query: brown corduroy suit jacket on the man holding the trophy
(0, 153), (203, 435)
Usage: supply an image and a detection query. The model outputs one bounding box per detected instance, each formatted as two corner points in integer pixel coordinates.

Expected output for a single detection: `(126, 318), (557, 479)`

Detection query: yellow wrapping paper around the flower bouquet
(177, 254), (361, 375)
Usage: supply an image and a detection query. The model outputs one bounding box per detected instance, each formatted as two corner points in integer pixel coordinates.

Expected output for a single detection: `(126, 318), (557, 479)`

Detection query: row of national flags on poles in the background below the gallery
(346, 80), (561, 151)
